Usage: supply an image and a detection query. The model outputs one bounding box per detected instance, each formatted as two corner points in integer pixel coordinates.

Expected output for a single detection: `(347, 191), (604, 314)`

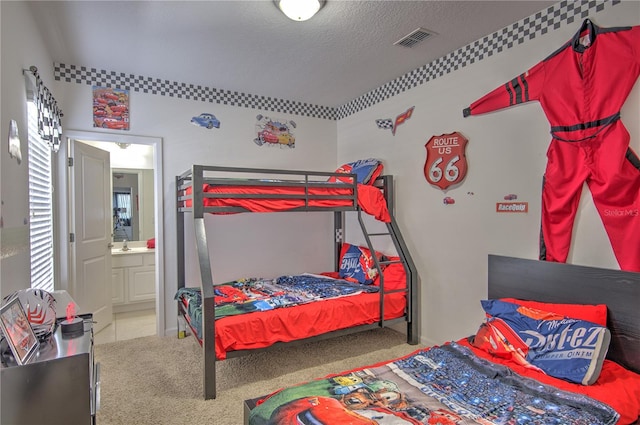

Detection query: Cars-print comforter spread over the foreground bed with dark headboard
(249, 339), (640, 425)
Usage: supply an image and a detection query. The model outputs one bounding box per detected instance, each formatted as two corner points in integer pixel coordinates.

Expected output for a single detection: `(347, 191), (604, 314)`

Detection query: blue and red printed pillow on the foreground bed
(473, 300), (611, 385)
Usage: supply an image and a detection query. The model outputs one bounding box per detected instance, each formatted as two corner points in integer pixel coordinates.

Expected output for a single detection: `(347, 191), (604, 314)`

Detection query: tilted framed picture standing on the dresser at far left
(0, 297), (40, 365)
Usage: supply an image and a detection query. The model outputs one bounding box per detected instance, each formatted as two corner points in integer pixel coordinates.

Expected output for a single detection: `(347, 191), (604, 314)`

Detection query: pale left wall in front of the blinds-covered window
(0, 1), (53, 297)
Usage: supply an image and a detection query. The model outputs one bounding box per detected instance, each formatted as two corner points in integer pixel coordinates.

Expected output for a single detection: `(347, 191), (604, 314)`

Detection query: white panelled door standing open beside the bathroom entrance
(69, 141), (113, 332)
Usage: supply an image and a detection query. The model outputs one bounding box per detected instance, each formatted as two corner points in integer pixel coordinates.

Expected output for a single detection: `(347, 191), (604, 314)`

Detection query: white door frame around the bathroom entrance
(59, 130), (166, 336)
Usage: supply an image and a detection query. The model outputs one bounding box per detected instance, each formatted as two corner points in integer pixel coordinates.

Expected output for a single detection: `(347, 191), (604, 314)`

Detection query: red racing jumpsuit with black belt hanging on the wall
(463, 19), (640, 272)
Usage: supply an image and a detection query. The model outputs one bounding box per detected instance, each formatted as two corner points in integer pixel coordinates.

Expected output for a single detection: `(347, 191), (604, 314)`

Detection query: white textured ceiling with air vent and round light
(30, 0), (556, 107)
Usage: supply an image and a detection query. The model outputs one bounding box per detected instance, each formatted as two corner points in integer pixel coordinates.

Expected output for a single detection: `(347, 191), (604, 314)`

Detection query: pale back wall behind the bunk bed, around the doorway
(60, 82), (336, 332)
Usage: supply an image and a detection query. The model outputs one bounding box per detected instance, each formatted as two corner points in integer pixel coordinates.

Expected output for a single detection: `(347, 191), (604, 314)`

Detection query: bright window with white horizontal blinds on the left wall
(27, 101), (54, 292)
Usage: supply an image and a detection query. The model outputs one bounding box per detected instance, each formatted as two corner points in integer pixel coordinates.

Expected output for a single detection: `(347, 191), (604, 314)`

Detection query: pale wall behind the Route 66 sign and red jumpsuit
(338, 1), (640, 343)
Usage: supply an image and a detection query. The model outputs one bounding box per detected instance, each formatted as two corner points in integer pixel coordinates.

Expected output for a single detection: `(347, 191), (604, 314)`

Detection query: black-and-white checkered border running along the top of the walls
(54, 0), (621, 120)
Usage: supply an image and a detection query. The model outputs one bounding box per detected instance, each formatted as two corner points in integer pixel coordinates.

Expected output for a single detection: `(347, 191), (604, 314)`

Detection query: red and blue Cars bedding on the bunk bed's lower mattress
(175, 269), (406, 360)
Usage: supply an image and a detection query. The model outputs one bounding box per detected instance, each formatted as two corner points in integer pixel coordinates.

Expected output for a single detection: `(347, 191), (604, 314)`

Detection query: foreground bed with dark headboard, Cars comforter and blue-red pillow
(244, 255), (640, 425)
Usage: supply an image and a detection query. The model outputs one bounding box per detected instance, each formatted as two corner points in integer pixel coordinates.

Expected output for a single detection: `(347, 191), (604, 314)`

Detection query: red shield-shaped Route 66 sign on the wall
(424, 131), (469, 190)
